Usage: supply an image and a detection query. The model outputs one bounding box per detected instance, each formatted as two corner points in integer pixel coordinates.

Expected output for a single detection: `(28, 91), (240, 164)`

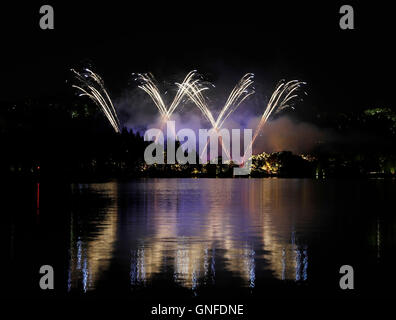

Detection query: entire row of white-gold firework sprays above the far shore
(72, 69), (306, 163)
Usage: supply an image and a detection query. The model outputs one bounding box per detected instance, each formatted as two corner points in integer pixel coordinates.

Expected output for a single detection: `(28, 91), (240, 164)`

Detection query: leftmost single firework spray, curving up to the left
(71, 68), (121, 133)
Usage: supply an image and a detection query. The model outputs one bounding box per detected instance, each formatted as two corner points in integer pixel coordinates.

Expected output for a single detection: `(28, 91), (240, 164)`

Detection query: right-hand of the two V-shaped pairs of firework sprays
(179, 73), (254, 159)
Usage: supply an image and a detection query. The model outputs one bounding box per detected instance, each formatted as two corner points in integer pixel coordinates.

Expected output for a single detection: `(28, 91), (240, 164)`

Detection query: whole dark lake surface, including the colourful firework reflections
(1, 179), (396, 302)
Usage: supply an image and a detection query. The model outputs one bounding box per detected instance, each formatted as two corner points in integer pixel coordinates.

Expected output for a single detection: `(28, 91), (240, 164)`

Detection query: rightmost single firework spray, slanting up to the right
(242, 80), (306, 163)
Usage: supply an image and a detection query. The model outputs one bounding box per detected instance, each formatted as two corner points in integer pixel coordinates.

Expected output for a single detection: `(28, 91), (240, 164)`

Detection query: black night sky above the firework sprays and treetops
(0, 1), (395, 118)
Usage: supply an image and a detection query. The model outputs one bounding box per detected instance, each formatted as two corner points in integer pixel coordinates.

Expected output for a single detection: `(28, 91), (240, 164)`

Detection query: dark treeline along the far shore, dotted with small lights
(0, 97), (396, 180)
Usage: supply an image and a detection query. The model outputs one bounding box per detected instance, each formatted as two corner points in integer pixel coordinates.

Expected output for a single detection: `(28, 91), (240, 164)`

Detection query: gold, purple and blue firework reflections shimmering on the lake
(68, 179), (320, 291)
